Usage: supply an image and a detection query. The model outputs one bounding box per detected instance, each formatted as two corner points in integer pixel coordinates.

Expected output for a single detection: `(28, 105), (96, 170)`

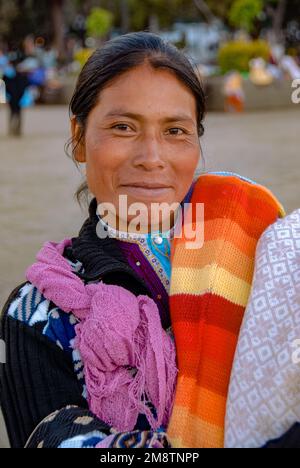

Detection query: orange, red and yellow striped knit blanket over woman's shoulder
(168, 174), (284, 448)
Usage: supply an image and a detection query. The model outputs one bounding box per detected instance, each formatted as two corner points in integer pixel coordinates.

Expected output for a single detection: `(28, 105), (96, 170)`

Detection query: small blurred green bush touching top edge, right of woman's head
(229, 0), (264, 33)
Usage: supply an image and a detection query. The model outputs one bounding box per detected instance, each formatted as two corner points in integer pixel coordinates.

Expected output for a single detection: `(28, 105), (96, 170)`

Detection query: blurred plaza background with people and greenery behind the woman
(0, 0), (300, 446)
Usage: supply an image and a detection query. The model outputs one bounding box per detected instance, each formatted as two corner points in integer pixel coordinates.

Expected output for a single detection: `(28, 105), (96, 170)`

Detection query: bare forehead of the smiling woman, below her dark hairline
(92, 64), (196, 119)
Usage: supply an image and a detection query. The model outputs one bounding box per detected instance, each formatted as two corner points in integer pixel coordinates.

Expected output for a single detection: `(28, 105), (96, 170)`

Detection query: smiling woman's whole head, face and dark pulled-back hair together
(70, 33), (205, 232)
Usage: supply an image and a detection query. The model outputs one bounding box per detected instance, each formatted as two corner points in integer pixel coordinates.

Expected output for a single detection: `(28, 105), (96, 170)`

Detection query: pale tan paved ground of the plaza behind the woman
(0, 106), (300, 447)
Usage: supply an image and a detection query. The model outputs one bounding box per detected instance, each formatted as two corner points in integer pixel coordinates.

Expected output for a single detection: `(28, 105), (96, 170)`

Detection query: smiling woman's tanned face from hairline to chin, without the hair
(72, 64), (201, 230)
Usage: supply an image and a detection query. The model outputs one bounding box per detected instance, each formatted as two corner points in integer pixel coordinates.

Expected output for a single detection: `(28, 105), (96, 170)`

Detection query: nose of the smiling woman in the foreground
(133, 135), (166, 171)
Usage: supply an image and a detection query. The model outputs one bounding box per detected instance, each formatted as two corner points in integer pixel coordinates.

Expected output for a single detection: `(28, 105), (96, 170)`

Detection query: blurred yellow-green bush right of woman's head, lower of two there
(218, 41), (270, 73)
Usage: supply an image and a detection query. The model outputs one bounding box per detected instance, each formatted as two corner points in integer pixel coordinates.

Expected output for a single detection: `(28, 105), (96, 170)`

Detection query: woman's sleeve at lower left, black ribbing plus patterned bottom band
(0, 283), (168, 448)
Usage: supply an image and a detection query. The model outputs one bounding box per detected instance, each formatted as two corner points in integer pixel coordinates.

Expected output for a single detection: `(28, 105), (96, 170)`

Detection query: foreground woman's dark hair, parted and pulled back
(65, 31), (205, 204)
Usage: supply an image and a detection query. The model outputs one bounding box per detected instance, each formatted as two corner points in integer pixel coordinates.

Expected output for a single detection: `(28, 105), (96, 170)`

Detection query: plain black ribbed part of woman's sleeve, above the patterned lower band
(0, 283), (96, 447)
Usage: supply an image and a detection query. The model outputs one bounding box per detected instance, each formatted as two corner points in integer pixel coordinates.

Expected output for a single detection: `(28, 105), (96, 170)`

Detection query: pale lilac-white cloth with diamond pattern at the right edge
(225, 210), (300, 448)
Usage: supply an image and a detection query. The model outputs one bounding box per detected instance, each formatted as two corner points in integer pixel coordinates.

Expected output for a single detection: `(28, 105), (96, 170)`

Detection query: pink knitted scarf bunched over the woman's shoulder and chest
(26, 239), (177, 432)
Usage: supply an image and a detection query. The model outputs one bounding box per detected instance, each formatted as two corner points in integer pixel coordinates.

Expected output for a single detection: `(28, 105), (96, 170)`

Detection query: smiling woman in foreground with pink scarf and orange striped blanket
(1, 32), (300, 448)
